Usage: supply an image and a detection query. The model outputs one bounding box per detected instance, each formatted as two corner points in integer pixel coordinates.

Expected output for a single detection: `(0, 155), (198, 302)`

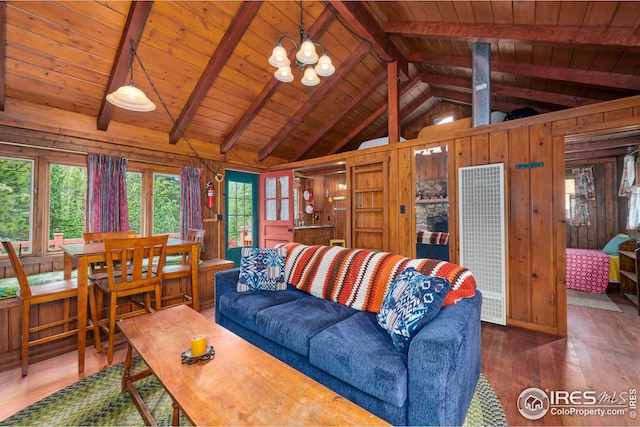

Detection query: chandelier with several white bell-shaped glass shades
(269, 1), (336, 86)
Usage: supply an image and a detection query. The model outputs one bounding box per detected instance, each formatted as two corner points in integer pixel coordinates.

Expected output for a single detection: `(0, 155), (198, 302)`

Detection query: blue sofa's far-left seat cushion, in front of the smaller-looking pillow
(218, 287), (308, 332)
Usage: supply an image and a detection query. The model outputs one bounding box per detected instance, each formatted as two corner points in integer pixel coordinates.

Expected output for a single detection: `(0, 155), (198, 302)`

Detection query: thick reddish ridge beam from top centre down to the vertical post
(329, 1), (410, 80)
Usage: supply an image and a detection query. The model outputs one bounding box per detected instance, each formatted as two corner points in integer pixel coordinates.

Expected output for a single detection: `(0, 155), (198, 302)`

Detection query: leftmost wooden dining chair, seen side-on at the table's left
(2, 240), (100, 377)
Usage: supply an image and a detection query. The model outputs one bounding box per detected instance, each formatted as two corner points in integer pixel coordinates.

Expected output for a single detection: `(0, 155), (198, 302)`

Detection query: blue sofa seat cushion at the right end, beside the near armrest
(309, 312), (408, 407)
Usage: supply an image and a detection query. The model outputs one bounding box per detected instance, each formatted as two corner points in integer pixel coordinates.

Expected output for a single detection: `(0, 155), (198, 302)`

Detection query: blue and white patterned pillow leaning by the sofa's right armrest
(377, 267), (451, 353)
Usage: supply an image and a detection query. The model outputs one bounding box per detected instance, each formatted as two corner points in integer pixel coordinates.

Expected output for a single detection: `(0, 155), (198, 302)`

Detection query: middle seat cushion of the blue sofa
(256, 295), (356, 357)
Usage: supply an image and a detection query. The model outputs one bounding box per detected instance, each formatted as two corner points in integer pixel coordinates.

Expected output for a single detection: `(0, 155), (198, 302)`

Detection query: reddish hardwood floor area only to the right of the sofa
(482, 294), (640, 426)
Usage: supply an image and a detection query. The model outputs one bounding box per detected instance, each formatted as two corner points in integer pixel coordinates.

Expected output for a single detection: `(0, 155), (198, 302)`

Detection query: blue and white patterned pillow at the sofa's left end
(236, 248), (287, 292)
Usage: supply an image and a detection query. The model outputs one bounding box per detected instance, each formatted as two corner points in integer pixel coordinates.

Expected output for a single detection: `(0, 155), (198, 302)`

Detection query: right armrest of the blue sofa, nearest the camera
(407, 290), (482, 425)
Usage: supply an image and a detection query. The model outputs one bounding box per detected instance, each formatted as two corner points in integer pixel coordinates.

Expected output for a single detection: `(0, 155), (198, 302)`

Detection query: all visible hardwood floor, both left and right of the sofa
(0, 295), (640, 426)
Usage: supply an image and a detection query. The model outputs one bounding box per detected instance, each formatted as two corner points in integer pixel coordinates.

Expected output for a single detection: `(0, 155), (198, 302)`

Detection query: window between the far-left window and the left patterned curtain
(47, 164), (87, 250)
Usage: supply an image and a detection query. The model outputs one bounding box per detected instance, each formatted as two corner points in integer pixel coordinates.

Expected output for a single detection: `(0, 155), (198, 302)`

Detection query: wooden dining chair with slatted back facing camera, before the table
(90, 234), (169, 363)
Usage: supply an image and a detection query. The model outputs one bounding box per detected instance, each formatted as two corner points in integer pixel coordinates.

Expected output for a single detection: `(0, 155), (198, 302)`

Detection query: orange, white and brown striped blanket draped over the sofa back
(279, 243), (476, 313)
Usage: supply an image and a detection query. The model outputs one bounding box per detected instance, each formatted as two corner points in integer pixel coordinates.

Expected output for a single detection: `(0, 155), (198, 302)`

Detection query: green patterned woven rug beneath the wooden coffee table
(0, 357), (506, 427)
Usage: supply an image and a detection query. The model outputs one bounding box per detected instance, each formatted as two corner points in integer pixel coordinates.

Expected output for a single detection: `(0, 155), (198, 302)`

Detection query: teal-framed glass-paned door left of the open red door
(225, 170), (258, 267)
